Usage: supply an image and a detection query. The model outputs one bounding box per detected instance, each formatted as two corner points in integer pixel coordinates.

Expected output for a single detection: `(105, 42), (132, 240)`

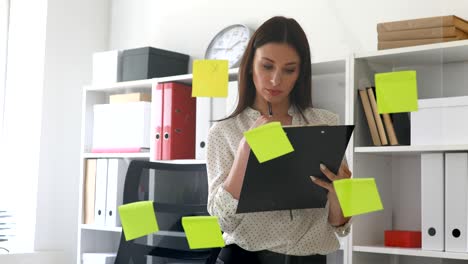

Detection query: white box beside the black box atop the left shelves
(93, 50), (122, 84)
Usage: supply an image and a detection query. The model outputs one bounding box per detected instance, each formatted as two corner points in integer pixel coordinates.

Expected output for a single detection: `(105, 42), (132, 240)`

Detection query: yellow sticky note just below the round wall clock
(192, 60), (229, 97)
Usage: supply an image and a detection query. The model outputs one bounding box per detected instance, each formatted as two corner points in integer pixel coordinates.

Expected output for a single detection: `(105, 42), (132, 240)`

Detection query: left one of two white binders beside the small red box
(421, 153), (445, 251)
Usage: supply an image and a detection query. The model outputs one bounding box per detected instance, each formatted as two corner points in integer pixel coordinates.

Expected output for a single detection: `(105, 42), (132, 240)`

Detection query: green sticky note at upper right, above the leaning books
(375, 71), (418, 114)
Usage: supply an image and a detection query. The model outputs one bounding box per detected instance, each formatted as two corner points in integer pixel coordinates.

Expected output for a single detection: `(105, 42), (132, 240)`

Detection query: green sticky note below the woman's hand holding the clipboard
(333, 178), (383, 217)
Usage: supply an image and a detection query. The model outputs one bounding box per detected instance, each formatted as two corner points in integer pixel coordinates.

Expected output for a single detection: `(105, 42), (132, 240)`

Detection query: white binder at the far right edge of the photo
(445, 153), (468, 252)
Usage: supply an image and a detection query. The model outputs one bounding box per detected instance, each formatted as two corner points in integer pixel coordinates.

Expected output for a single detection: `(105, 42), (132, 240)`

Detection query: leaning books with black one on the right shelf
(358, 87), (411, 146)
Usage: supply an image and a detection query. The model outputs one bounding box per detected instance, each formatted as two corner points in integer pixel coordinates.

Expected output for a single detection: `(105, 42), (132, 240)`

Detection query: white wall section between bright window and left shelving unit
(35, 0), (110, 263)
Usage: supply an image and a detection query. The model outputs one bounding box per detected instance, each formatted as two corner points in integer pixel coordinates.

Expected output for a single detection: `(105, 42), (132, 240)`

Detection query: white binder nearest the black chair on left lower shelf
(106, 159), (129, 227)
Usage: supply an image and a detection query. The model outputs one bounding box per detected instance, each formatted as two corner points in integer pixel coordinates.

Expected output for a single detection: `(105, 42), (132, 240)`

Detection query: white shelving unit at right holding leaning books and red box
(348, 40), (468, 264)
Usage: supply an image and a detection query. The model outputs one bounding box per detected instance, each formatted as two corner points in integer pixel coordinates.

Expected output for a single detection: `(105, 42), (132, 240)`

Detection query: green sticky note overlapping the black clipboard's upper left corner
(244, 122), (294, 163)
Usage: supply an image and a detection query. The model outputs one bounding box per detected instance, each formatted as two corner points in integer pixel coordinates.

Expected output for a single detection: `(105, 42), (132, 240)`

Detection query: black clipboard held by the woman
(236, 125), (354, 213)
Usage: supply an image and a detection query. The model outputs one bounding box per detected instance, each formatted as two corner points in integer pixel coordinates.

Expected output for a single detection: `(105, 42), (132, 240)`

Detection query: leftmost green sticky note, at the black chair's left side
(119, 201), (159, 241)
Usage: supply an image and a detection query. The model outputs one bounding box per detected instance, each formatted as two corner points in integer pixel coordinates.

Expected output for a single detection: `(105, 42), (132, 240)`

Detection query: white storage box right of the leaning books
(411, 96), (468, 145)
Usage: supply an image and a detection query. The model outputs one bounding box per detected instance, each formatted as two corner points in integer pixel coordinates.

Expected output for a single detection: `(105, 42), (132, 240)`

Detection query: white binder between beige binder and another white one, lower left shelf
(94, 159), (107, 225)
